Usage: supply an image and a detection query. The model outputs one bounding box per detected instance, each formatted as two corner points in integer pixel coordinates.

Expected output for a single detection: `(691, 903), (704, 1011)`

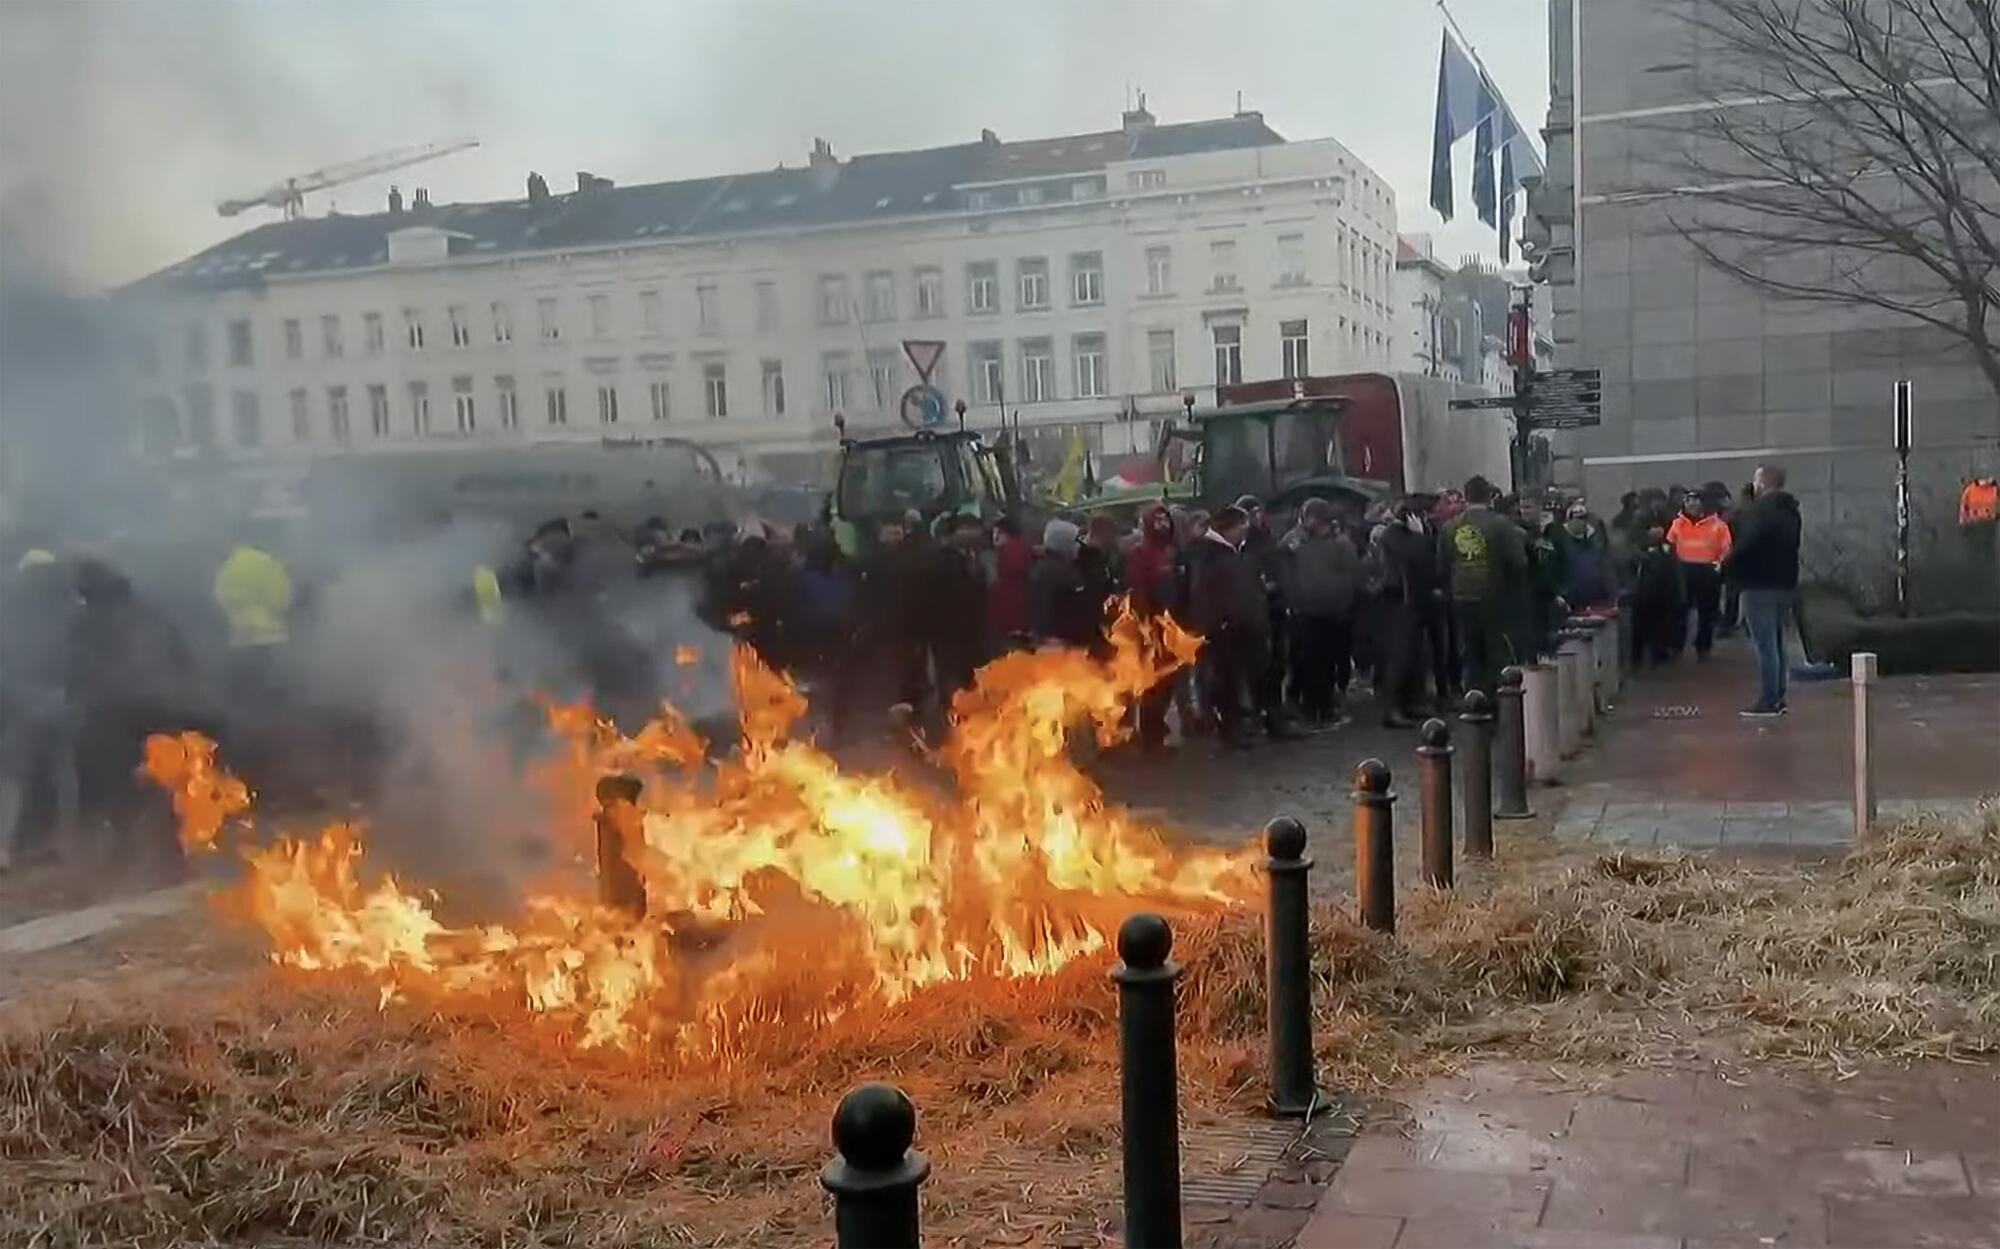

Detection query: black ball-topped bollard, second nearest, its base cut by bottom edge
(1112, 915), (1180, 1249)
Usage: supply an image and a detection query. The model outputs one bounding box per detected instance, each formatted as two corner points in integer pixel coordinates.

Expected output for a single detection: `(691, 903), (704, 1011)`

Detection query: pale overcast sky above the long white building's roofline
(0, 0), (1548, 284)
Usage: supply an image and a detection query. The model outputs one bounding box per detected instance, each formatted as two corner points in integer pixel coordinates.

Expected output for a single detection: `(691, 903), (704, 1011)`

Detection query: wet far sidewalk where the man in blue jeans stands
(1536, 641), (2000, 851)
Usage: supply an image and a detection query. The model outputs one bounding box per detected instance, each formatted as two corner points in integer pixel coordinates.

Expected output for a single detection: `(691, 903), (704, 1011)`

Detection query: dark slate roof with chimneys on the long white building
(145, 110), (1284, 290)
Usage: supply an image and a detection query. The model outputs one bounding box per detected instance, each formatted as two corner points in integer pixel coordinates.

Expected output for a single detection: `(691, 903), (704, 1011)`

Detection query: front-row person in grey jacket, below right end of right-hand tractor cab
(1280, 498), (1362, 727)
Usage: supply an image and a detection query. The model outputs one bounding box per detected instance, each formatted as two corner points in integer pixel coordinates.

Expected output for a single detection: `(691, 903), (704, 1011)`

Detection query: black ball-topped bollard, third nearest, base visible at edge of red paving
(1264, 815), (1324, 1119)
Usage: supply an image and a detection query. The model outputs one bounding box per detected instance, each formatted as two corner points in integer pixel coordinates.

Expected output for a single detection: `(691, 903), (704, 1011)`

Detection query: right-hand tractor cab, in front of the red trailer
(1162, 394), (1384, 510)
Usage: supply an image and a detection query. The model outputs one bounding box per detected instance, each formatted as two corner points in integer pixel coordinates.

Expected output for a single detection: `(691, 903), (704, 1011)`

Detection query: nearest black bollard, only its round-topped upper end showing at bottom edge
(820, 1083), (930, 1249)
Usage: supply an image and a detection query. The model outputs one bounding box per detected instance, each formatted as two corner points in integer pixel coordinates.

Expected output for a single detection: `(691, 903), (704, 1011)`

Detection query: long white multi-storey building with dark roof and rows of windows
(120, 102), (1402, 488)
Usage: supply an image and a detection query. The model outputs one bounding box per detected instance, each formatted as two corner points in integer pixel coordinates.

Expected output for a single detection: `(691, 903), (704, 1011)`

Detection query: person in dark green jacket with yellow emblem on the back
(1444, 476), (1534, 695)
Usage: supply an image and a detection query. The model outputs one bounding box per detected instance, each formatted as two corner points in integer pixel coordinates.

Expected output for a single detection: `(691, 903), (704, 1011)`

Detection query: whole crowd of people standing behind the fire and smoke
(0, 466), (1800, 869)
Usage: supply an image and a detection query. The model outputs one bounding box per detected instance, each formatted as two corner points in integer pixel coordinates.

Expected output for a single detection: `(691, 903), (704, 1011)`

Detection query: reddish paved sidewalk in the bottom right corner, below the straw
(1296, 1063), (2000, 1249)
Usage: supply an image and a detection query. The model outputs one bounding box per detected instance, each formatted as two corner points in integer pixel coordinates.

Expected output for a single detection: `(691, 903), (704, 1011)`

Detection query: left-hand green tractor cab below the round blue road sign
(828, 430), (1020, 554)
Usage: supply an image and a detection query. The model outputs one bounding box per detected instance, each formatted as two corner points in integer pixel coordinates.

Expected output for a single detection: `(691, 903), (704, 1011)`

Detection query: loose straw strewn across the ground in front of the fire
(0, 811), (2000, 1247)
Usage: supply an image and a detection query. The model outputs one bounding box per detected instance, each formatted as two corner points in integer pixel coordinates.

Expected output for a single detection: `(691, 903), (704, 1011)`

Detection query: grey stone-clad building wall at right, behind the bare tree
(1530, 0), (2000, 566)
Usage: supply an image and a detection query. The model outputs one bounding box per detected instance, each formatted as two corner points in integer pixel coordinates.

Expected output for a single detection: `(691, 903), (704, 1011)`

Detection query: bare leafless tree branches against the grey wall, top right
(1670, 0), (2000, 394)
